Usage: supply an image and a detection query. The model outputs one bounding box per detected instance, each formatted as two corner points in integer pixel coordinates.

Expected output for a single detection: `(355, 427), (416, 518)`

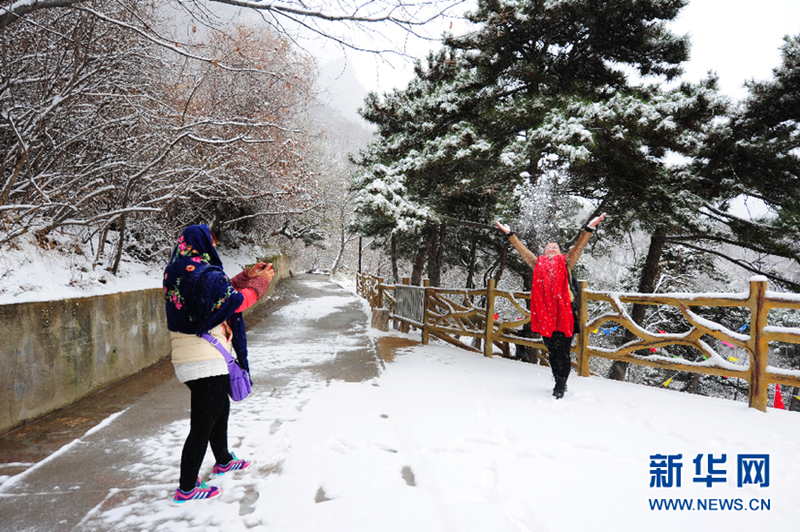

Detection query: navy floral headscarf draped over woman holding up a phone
(164, 225), (247, 366)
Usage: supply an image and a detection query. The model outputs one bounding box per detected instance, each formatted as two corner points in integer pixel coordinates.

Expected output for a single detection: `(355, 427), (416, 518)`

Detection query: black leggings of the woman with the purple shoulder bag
(180, 375), (232, 491)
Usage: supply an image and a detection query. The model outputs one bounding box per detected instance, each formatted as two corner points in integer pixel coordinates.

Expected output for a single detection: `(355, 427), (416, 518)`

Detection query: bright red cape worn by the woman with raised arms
(531, 255), (575, 338)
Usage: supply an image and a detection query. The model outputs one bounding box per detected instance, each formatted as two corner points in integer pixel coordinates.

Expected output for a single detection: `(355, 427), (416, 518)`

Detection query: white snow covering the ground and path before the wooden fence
(1, 278), (800, 532)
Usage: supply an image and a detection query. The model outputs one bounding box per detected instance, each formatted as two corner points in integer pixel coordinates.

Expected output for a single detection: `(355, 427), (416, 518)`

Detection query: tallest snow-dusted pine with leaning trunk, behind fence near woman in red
(449, 0), (724, 377)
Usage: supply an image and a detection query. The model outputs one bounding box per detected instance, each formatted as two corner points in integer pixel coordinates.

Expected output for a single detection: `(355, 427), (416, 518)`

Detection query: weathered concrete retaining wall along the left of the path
(0, 251), (290, 434)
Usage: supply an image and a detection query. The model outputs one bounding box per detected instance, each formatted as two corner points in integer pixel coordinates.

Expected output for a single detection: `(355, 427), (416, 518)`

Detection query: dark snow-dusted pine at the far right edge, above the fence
(680, 35), (800, 290)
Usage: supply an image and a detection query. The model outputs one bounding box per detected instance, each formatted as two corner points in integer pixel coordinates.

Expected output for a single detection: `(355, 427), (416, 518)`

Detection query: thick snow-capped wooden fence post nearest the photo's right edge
(748, 277), (769, 412)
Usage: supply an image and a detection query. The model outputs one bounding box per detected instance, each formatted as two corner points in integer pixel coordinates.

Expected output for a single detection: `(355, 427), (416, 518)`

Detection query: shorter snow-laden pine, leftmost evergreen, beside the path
(353, 51), (513, 285)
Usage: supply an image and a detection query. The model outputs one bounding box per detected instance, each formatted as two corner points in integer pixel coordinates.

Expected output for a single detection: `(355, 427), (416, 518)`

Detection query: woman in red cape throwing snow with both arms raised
(496, 213), (606, 399)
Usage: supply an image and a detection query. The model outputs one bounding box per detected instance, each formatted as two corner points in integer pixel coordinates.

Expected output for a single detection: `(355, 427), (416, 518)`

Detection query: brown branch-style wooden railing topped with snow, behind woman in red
(357, 274), (800, 412)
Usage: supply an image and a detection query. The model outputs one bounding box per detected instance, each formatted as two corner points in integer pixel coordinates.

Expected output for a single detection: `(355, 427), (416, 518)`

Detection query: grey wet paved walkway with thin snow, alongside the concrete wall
(0, 274), (381, 531)
